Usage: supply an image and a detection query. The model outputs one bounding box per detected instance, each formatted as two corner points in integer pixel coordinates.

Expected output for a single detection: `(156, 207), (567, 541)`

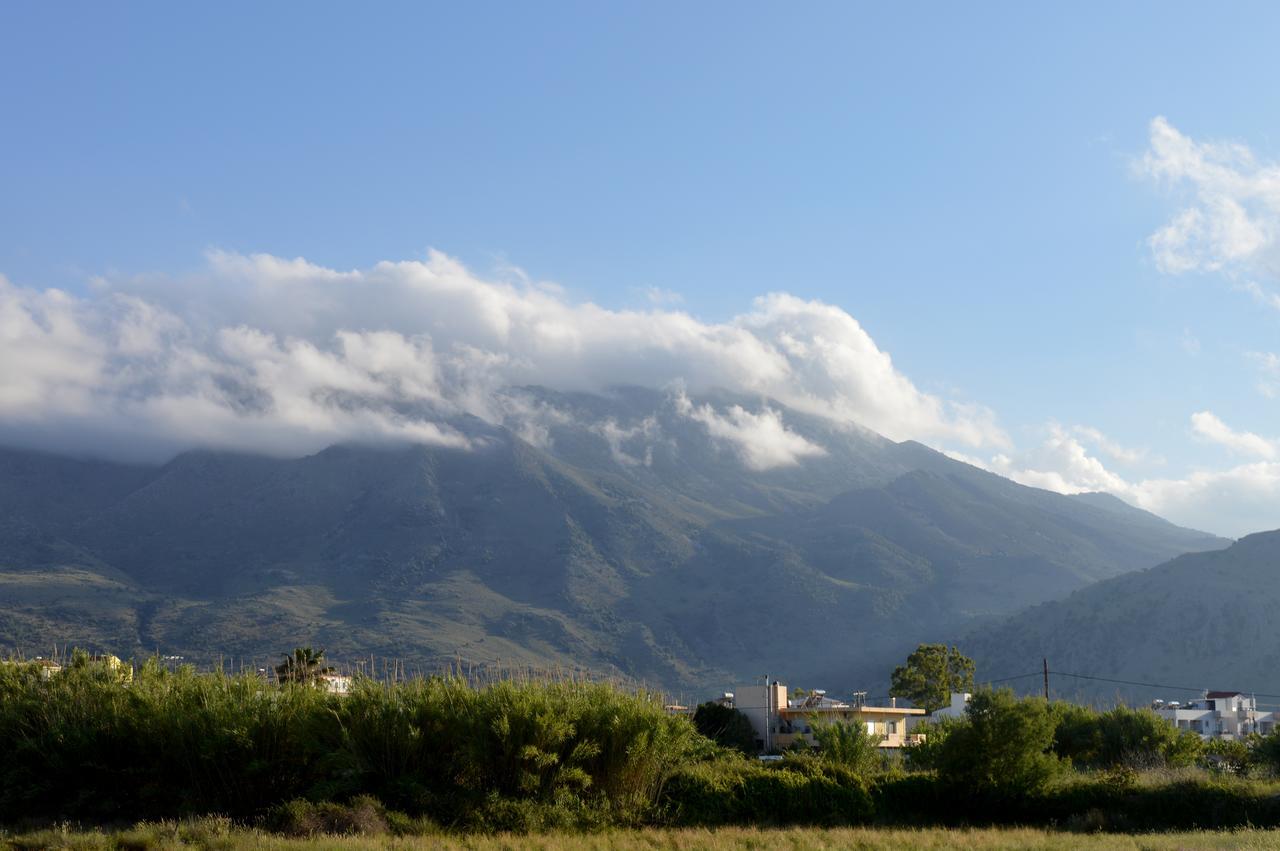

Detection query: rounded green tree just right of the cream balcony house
(929, 688), (1060, 797)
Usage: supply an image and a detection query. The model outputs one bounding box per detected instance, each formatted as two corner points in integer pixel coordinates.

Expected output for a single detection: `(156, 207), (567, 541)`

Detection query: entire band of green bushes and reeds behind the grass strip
(0, 664), (1280, 836)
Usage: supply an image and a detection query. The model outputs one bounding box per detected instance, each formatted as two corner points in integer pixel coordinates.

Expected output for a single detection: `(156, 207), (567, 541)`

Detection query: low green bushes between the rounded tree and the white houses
(1050, 703), (1202, 768)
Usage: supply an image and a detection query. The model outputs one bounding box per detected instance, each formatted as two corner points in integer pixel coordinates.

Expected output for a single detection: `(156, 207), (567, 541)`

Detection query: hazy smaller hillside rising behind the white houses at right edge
(961, 532), (1280, 703)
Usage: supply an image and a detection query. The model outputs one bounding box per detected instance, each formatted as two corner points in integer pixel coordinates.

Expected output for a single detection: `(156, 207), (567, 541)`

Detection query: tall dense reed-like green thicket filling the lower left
(0, 664), (701, 828)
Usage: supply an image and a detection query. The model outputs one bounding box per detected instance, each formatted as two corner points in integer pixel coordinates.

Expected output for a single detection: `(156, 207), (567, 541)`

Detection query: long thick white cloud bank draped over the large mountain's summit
(0, 252), (1009, 468)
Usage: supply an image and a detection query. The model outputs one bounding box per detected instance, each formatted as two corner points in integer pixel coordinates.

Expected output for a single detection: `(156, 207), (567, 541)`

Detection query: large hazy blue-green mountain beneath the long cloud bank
(0, 388), (1226, 688)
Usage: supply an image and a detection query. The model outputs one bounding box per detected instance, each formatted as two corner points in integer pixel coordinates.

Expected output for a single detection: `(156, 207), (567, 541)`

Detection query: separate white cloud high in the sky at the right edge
(1139, 116), (1280, 274)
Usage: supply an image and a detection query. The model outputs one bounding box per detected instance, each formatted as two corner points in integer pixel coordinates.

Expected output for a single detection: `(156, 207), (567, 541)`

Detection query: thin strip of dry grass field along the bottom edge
(0, 820), (1280, 851)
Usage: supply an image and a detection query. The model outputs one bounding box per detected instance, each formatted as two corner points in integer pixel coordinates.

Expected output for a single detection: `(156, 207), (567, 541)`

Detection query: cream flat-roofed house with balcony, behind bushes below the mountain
(724, 681), (924, 751)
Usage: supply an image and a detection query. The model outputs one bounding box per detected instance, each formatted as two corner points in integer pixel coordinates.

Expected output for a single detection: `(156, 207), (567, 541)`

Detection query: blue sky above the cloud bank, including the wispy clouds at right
(0, 3), (1280, 534)
